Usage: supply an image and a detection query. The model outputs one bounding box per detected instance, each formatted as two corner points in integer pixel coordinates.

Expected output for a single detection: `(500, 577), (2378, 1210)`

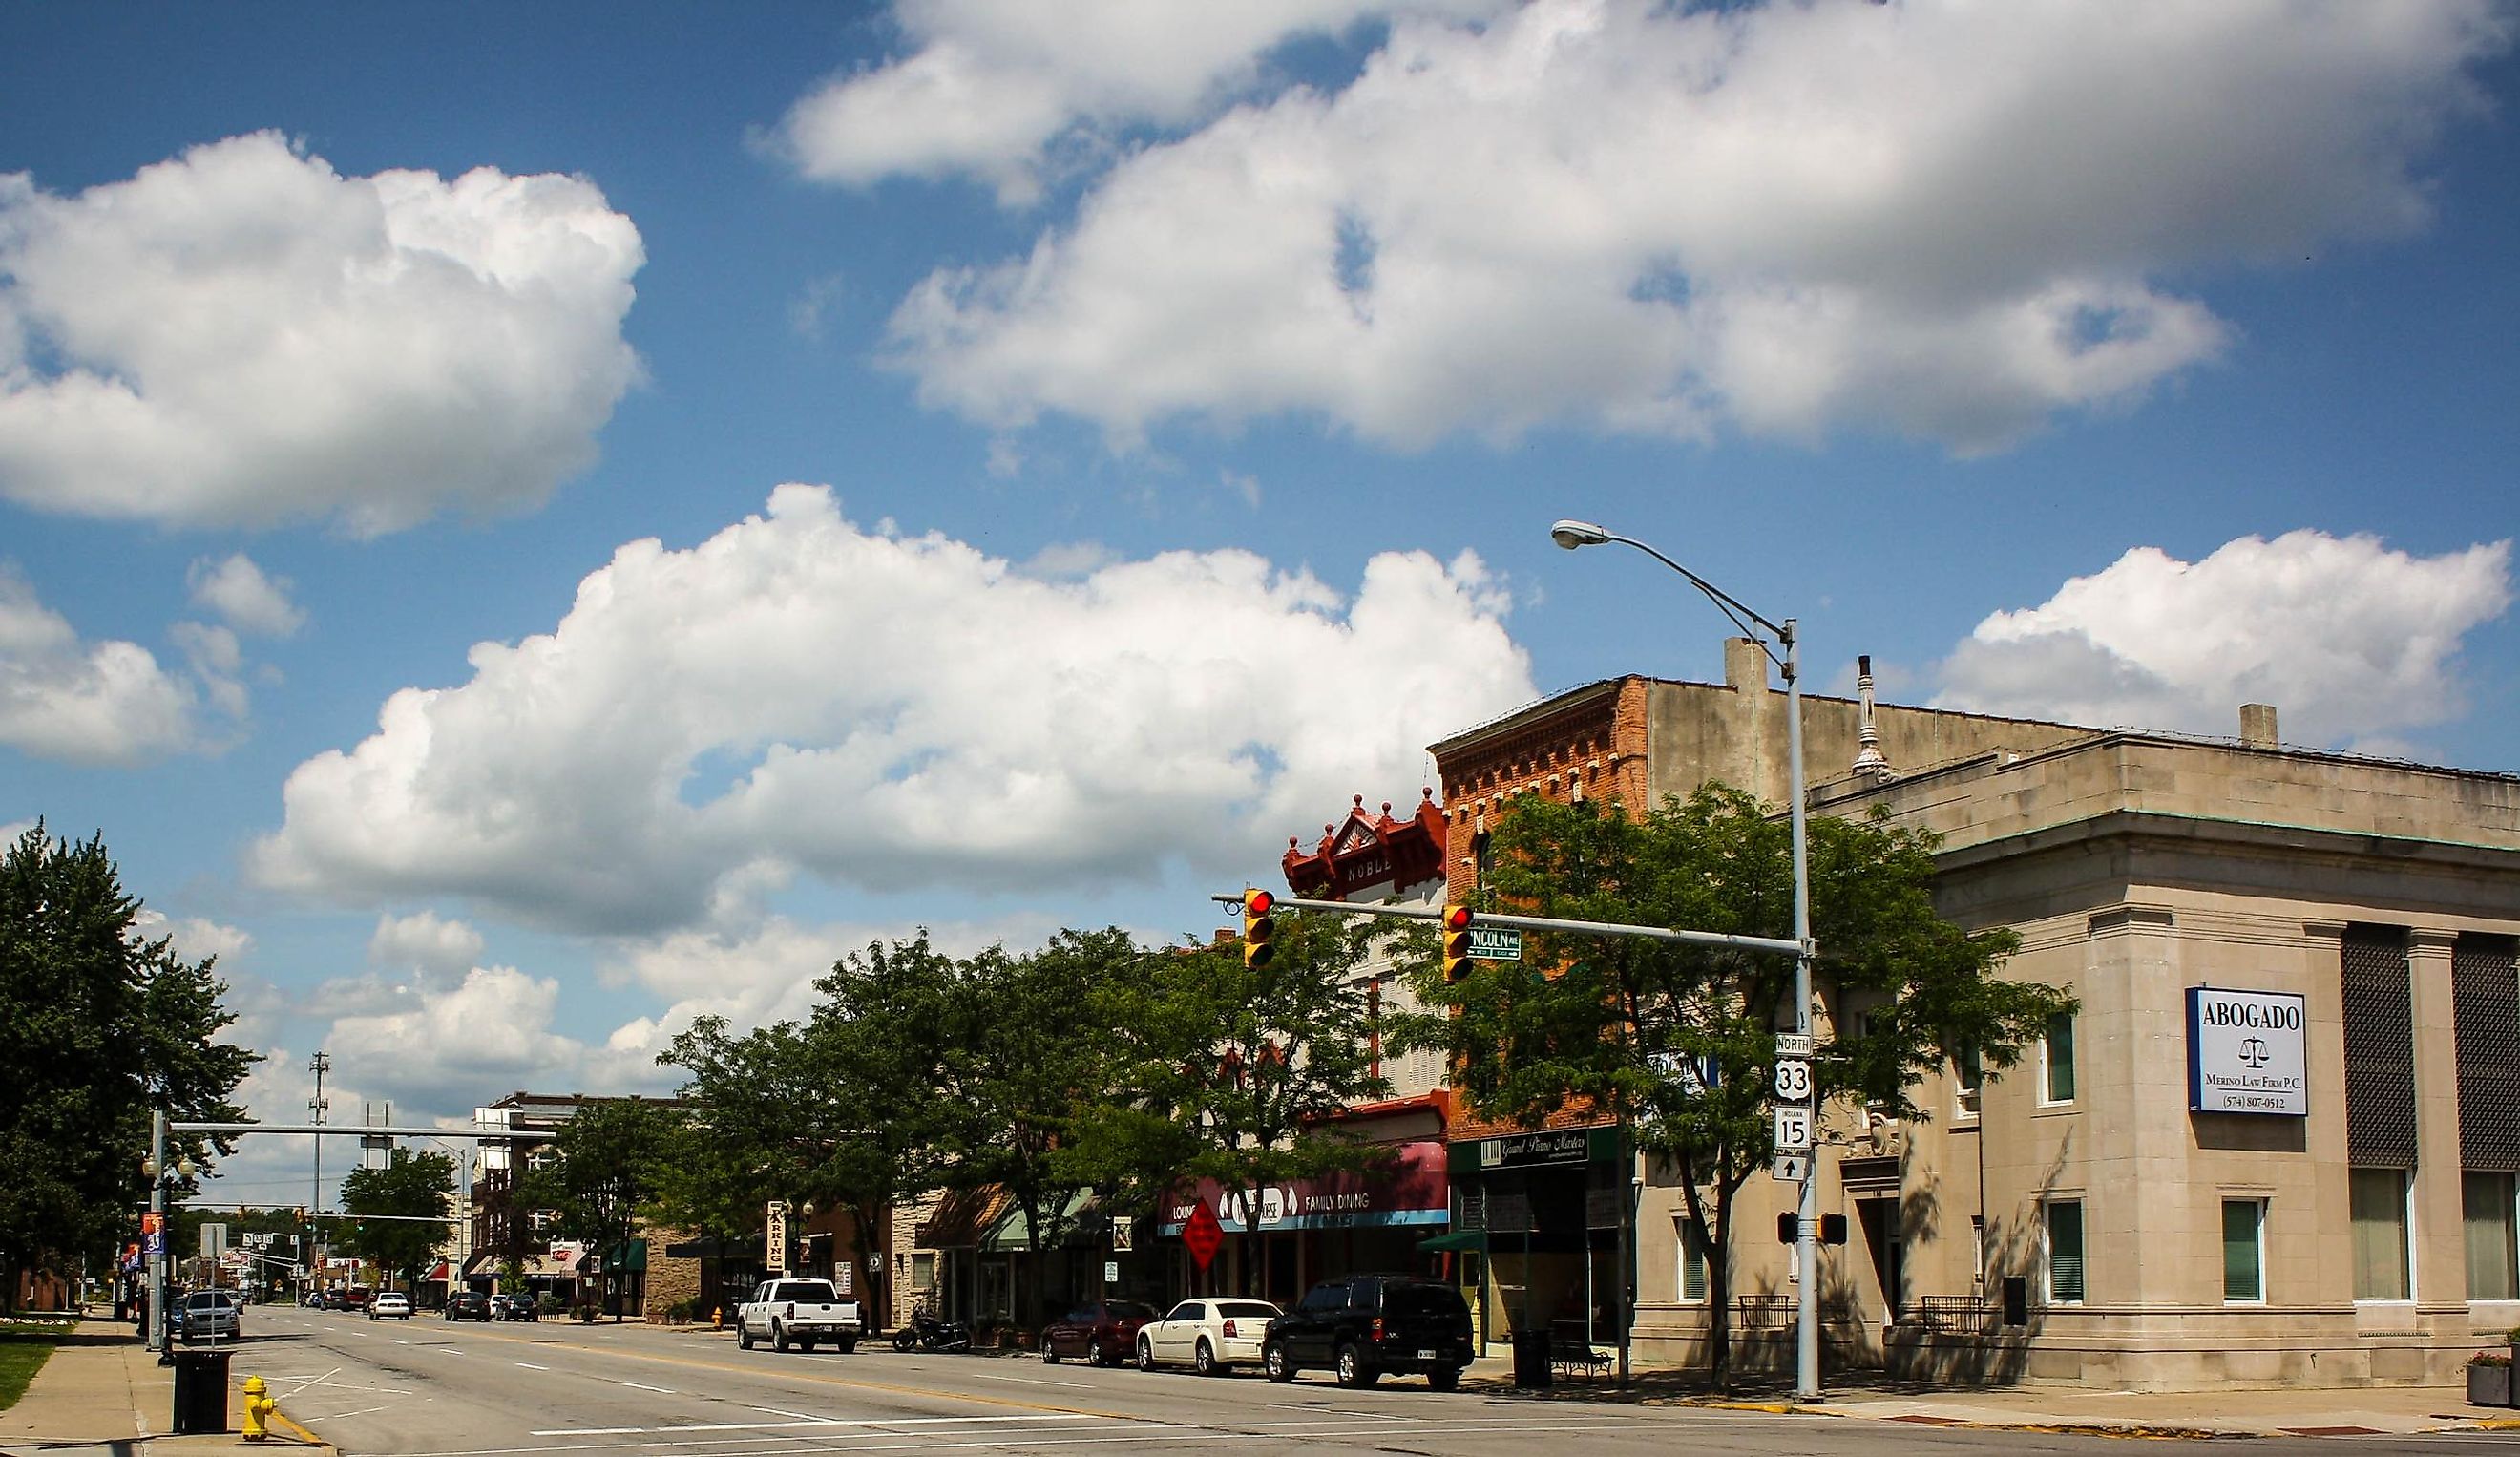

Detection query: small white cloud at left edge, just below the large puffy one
(0, 562), (199, 767)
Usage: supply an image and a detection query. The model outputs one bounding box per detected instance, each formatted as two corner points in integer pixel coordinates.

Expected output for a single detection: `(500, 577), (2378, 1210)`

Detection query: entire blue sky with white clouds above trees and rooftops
(0, 0), (2520, 1202)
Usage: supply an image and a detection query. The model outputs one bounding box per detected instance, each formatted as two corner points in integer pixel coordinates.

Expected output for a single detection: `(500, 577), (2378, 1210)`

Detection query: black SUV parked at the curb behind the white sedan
(1260, 1276), (1472, 1391)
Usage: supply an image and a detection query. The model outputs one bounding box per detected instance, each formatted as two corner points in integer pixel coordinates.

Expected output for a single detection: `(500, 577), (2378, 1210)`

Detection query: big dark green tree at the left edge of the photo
(0, 822), (260, 1303)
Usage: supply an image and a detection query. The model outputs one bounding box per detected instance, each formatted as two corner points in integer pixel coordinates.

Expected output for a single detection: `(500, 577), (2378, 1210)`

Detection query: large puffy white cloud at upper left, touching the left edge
(0, 131), (645, 535)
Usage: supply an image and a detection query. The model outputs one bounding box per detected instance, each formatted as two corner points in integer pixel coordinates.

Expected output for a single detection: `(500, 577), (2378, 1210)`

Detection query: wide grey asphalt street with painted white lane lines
(211, 1306), (2515, 1457)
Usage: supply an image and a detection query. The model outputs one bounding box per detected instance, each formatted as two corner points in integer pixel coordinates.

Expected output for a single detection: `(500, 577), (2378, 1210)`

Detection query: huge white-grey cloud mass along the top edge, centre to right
(861, 0), (2512, 452)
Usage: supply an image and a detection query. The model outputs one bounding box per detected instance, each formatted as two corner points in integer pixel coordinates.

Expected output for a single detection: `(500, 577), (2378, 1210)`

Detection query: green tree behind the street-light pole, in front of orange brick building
(1394, 784), (2074, 1383)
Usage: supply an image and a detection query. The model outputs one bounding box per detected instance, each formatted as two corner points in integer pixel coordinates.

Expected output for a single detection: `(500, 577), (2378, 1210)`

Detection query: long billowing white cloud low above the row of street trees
(252, 487), (1532, 933)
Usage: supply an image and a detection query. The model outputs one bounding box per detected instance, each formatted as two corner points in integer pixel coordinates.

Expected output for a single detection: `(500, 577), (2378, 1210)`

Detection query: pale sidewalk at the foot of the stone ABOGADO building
(1464, 1356), (2520, 1437)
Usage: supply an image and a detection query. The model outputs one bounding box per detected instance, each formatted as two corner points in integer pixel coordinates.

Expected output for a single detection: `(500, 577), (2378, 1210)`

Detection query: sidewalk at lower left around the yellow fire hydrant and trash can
(0, 1319), (332, 1457)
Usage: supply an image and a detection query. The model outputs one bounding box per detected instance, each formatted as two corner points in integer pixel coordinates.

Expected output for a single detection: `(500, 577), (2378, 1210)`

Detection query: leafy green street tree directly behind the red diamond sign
(1076, 915), (1391, 1288)
